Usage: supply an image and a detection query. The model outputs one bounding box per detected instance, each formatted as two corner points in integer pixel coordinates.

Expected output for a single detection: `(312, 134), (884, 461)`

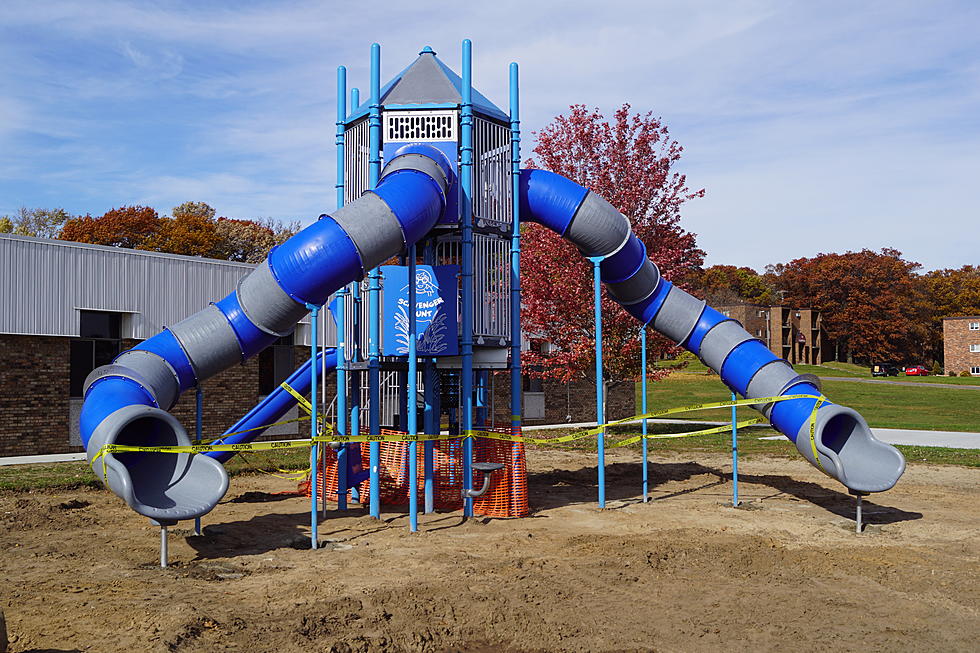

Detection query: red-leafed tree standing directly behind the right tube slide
(521, 104), (704, 382)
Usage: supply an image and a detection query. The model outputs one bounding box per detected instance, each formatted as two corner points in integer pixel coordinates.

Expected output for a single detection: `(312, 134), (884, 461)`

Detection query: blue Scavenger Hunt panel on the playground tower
(381, 265), (459, 356)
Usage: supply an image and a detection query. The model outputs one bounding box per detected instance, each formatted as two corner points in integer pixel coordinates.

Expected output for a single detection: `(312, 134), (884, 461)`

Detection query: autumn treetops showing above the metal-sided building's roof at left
(0, 202), (300, 263)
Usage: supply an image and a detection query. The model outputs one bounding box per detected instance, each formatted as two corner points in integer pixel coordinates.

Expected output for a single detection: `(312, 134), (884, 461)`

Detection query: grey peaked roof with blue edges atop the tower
(350, 46), (509, 120)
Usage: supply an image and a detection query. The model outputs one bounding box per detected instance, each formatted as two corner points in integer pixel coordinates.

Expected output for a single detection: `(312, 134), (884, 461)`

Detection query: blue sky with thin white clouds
(0, 0), (980, 269)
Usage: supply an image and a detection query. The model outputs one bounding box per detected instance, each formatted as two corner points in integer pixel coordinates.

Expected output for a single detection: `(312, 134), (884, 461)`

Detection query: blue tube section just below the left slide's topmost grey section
(372, 169), (446, 244)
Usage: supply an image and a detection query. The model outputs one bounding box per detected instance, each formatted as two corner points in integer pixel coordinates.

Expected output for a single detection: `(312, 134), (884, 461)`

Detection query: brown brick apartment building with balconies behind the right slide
(716, 304), (831, 365)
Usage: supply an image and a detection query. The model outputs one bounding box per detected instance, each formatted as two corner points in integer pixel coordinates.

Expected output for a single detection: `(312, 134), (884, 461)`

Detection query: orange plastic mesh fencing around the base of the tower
(308, 430), (530, 517)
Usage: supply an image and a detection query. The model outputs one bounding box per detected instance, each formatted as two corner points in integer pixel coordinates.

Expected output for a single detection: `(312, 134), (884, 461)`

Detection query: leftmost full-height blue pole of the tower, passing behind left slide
(334, 66), (347, 516)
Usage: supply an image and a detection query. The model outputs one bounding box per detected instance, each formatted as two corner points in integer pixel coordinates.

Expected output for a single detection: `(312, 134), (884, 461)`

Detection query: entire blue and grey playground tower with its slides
(81, 41), (905, 548)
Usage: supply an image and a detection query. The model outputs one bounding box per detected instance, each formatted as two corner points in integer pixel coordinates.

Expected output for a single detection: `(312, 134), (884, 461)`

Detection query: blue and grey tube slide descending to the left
(81, 145), (454, 524)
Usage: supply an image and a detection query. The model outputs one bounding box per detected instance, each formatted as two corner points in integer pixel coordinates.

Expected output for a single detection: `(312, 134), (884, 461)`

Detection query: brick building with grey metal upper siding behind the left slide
(0, 234), (314, 456)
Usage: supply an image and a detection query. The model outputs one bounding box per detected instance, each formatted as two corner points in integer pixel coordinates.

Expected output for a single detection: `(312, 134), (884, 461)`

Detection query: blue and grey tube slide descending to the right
(520, 170), (905, 493)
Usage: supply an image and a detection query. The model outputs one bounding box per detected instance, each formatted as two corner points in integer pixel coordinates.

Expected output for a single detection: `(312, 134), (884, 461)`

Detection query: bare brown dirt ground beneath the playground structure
(0, 451), (980, 653)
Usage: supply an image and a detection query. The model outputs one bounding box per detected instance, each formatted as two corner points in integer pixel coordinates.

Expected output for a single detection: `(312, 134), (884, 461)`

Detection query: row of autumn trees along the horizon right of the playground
(685, 248), (980, 366)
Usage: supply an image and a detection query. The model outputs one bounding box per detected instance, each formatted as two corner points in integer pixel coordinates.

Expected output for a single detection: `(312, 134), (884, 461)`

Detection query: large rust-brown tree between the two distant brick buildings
(766, 248), (926, 363)
